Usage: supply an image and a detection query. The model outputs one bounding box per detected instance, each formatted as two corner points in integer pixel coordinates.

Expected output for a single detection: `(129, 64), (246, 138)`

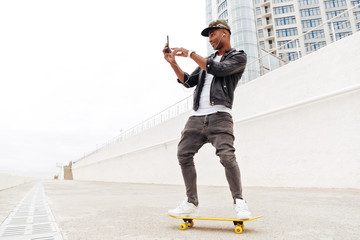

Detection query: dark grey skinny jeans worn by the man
(177, 112), (242, 206)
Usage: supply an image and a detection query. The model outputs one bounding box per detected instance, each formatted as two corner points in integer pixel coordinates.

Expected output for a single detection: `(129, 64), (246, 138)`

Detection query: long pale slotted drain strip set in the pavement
(0, 183), (63, 240)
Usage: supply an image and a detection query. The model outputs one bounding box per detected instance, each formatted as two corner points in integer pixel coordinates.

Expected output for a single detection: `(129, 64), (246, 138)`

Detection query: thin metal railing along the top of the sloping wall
(74, 1), (360, 162)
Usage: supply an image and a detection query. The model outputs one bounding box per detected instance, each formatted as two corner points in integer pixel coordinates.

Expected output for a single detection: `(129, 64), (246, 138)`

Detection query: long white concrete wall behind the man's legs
(73, 33), (360, 188)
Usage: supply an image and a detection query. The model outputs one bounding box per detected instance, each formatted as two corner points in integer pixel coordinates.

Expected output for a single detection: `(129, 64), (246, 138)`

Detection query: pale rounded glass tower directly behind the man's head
(206, 0), (260, 84)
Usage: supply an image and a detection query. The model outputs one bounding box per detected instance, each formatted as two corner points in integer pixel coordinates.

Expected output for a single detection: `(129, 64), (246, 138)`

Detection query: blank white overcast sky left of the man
(0, 0), (207, 177)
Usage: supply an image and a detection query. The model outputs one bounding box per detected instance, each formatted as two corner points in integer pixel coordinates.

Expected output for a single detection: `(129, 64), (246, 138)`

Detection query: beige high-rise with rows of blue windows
(253, 0), (360, 61)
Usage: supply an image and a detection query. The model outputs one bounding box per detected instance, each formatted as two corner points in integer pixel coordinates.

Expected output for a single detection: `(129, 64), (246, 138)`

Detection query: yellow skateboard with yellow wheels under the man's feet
(168, 214), (262, 234)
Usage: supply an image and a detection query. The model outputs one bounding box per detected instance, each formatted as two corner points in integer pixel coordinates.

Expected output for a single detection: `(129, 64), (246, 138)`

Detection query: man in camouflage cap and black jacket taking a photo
(163, 20), (251, 219)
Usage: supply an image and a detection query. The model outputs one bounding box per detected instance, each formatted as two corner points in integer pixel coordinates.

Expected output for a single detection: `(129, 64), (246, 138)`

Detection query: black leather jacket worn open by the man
(178, 48), (247, 111)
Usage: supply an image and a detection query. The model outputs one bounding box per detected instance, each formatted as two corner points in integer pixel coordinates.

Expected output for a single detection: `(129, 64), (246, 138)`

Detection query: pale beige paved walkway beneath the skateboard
(0, 181), (360, 240)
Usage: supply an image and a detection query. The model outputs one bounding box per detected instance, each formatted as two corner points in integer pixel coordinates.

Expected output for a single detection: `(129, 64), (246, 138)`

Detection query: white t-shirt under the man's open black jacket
(192, 56), (231, 116)
